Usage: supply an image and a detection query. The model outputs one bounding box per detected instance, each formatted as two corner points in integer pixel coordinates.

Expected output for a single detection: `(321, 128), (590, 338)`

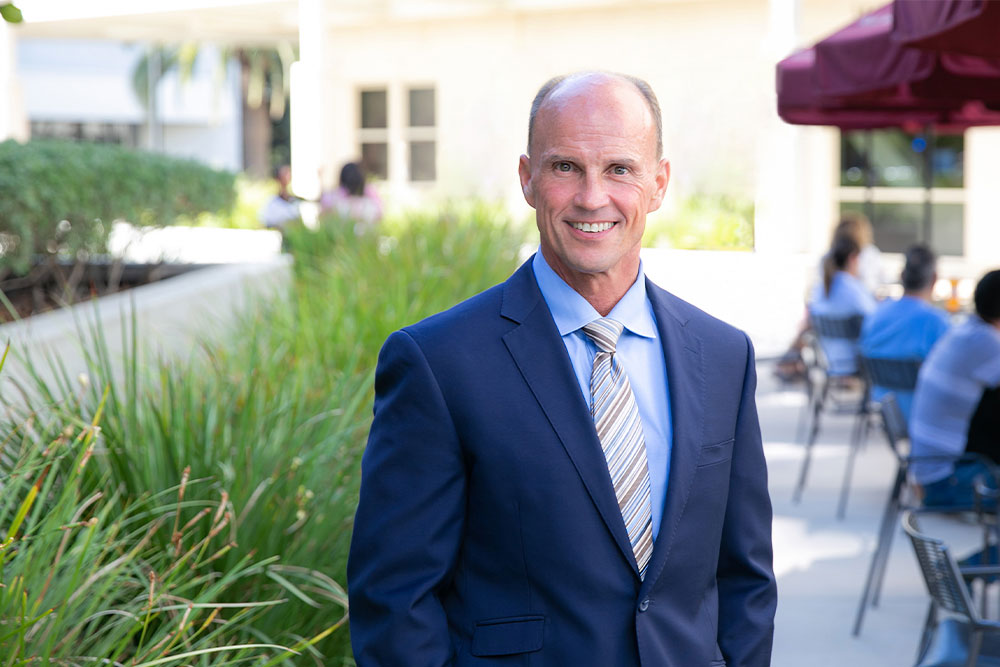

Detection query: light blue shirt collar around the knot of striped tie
(531, 248), (656, 338)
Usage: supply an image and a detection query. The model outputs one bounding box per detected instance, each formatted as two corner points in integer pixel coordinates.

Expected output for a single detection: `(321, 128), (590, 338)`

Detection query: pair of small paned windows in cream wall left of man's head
(358, 86), (437, 182)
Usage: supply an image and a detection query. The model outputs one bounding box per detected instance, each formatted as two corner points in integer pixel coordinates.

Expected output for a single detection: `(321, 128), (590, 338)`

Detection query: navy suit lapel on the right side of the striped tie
(640, 280), (706, 594)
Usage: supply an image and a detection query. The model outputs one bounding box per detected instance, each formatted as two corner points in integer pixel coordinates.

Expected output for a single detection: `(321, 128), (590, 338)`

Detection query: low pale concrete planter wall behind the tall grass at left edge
(0, 255), (291, 408)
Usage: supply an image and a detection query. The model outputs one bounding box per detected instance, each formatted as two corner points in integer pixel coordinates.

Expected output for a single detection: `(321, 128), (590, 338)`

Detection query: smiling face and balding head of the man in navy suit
(518, 77), (670, 296)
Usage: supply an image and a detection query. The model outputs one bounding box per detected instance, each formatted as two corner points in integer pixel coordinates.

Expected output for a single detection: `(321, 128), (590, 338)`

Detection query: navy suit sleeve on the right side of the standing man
(717, 338), (777, 667)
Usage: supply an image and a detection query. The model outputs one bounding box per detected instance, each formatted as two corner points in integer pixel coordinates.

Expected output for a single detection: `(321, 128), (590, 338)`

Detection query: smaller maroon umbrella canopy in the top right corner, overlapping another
(892, 0), (1000, 57)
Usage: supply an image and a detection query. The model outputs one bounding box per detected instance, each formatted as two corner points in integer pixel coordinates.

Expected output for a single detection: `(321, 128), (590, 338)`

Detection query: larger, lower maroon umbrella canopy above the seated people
(777, 5), (1000, 129)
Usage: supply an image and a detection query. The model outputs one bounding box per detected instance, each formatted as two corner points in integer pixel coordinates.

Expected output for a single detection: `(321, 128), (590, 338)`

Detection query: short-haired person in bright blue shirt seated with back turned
(861, 243), (948, 421)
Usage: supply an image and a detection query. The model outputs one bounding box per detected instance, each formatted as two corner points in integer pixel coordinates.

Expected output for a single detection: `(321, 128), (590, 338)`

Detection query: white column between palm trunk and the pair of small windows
(290, 0), (329, 204)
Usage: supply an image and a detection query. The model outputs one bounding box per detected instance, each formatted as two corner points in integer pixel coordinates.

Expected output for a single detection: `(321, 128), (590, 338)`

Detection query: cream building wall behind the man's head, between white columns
(324, 0), (773, 215)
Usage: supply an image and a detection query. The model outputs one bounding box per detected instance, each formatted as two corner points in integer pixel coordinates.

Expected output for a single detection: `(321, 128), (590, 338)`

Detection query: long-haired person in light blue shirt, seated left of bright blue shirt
(808, 235), (876, 376)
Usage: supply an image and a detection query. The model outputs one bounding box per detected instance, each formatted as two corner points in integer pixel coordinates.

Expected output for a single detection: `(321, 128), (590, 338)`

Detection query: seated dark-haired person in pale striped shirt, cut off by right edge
(910, 270), (1000, 506)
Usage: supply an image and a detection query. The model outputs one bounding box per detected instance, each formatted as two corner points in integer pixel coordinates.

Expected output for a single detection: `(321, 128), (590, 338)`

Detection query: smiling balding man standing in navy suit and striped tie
(348, 73), (776, 667)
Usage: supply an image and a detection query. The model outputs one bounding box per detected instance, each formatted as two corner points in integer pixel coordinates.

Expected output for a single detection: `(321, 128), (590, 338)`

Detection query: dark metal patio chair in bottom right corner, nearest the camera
(902, 511), (1000, 667)
